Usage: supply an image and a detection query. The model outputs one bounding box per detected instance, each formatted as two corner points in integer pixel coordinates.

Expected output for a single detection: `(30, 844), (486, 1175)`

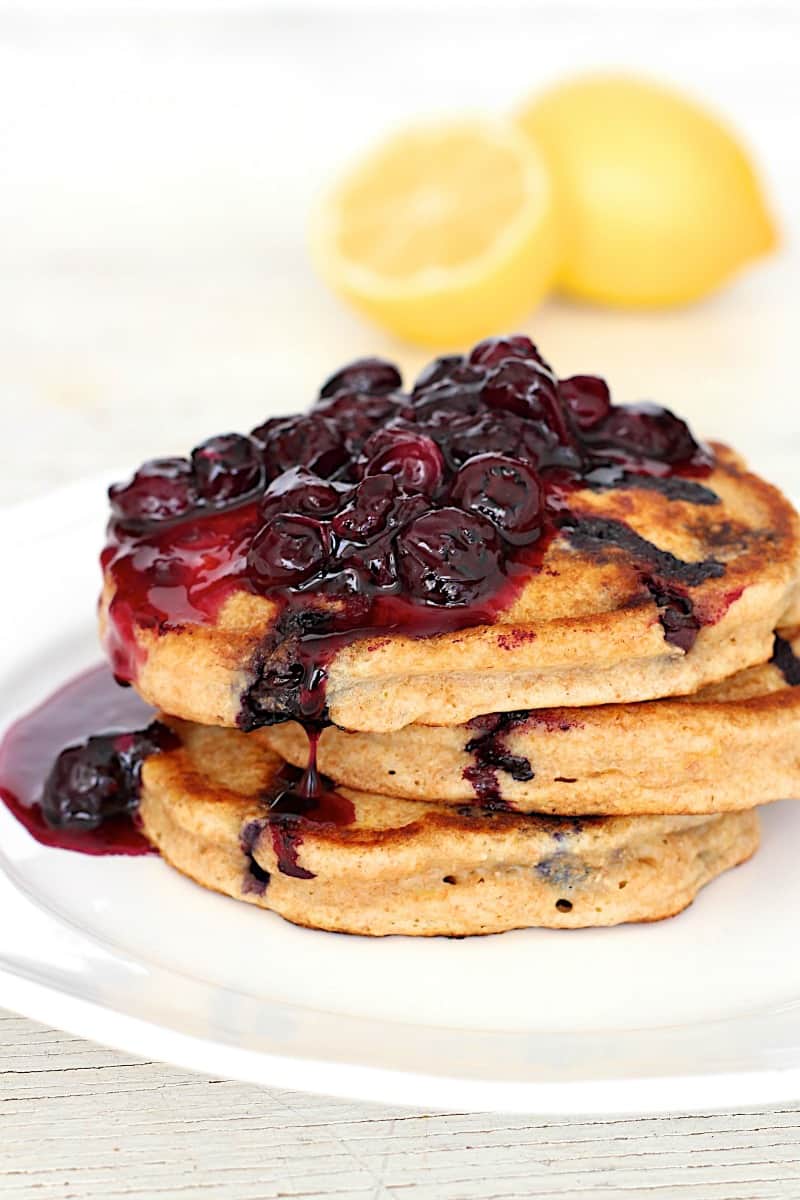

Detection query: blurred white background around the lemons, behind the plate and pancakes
(0, 0), (800, 499)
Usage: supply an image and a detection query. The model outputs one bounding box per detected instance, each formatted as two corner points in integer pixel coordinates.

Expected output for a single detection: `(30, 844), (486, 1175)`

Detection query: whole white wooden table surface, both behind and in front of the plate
(0, 0), (800, 1200)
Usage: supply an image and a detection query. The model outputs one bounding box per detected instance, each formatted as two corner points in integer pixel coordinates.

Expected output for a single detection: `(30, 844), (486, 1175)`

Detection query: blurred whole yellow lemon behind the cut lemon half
(517, 76), (777, 306)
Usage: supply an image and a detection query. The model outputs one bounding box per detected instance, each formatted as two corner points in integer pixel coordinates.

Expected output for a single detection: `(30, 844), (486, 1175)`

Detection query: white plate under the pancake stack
(0, 480), (800, 1114)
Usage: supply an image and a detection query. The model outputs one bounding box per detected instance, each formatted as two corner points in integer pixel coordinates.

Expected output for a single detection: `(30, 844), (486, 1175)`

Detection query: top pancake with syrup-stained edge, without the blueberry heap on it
(100, 446), (800, 733)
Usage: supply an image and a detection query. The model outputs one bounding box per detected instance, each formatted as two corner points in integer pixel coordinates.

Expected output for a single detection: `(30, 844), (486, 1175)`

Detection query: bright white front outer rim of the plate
(0, 945), (800, 1116)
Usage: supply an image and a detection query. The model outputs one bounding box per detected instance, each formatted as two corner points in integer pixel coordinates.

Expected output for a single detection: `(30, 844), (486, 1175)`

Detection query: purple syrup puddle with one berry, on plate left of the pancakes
(0, 665), (167, 854)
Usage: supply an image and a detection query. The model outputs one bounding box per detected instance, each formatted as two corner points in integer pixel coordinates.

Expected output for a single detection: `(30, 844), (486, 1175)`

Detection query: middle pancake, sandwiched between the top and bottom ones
(263, 630), (800, 815)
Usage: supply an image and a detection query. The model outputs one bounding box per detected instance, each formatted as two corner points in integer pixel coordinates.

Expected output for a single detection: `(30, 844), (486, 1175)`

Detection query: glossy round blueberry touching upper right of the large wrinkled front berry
(450, 454), (542, 544)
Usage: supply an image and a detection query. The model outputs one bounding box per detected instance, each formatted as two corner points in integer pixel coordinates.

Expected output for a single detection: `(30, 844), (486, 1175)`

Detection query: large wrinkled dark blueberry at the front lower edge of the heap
(397, 508), (501, 605)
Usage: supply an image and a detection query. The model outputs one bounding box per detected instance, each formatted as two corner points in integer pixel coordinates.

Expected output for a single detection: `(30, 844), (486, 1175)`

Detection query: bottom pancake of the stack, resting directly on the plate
(139, 721), (758, 936)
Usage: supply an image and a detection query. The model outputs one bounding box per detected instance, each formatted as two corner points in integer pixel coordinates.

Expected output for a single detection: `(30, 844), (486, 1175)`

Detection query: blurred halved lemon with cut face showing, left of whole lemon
(311, 120), (559, 348)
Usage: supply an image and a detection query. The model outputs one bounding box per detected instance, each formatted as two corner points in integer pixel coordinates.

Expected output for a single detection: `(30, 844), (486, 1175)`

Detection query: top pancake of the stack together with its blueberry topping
(101, 337), (800, 733)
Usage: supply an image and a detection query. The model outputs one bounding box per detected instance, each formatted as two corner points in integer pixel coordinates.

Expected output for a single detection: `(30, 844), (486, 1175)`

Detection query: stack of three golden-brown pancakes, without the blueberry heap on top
(101, 350), (800, 936)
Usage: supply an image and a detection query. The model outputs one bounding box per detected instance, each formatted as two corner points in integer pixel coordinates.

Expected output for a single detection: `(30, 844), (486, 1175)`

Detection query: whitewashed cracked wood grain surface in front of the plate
(0, 1013), (800, 1200)
